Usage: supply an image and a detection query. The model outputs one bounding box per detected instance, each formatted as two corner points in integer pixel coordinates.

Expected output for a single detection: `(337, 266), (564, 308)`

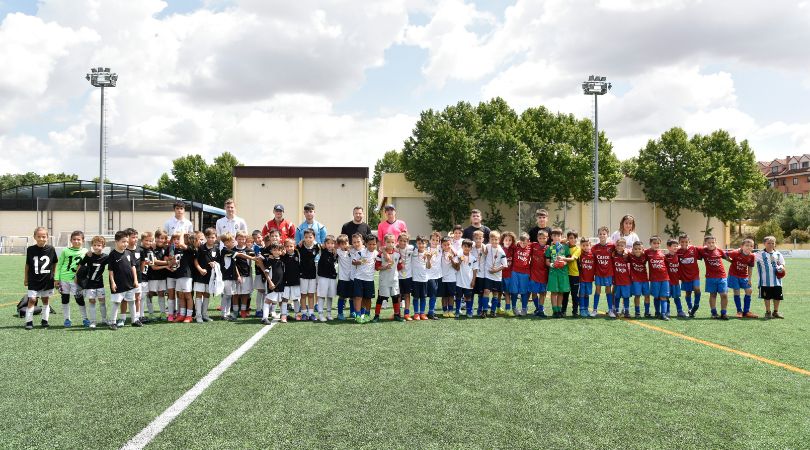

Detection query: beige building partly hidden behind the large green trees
(378, 173), (731, 247)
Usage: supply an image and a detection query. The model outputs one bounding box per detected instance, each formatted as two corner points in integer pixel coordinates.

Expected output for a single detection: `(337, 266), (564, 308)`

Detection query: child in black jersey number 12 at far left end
(23, 227), (59, 330)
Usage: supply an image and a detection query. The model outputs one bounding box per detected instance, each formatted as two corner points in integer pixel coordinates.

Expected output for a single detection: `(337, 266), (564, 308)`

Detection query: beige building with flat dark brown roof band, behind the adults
(233, 166), (368, 234)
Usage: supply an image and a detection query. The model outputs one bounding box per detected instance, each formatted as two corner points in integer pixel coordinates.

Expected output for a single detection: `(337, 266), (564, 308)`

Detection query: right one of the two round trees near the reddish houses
(690, 130), (766, 234)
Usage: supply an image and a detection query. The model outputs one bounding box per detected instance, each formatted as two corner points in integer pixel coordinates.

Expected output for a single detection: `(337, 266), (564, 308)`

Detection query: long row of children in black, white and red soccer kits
(19, 225), (785, 329)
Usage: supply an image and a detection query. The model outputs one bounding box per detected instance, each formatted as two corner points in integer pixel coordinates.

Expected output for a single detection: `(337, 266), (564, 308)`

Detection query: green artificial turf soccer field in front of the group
(0, 256), (810, 449)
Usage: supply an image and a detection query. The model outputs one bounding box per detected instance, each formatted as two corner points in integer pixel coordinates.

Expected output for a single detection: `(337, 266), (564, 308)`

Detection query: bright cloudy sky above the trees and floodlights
(0, 0), (810, 184)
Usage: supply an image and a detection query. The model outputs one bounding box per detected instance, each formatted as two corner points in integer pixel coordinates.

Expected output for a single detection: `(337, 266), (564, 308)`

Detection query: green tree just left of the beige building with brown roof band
(157, 152), (241, 205)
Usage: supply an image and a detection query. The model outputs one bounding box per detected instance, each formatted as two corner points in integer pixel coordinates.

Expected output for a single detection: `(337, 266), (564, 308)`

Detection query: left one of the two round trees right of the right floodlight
(625, 127), (705, 237)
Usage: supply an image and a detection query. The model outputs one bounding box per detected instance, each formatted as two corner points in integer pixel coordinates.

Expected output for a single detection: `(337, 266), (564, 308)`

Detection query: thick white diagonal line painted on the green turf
(121, 321), (278, 450)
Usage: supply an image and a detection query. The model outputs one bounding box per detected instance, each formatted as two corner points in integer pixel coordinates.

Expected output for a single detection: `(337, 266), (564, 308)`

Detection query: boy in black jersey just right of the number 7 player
(107, 231), (143, 330)
